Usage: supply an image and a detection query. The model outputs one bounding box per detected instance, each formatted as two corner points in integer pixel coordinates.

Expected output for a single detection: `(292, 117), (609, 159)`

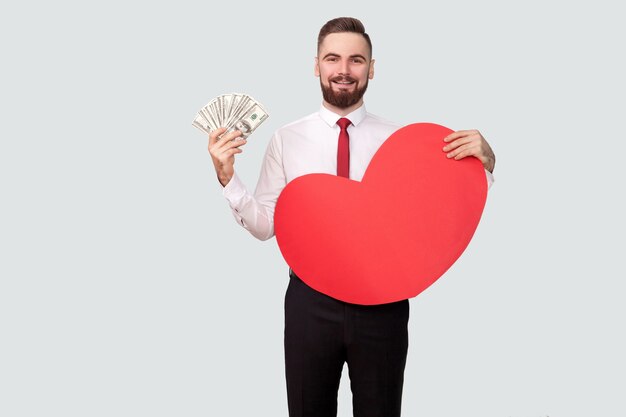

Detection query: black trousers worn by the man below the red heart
(285, 273), (409, 417)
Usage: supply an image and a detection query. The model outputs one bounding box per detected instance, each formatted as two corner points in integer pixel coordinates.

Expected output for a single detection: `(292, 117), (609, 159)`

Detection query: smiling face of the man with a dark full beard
(315, 32), (374, 109)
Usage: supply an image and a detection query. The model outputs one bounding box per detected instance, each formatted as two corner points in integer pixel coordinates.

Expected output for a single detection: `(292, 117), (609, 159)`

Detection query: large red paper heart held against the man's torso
(274, 123), (487, 305)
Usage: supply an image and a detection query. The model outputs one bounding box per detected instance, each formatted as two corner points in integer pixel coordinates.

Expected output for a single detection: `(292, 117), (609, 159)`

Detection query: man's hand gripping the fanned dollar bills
(209, 127), (248, 187)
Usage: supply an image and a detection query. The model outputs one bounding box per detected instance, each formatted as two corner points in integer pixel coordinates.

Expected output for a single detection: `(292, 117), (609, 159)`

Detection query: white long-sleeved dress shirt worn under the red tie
(224, 105), (493, 240)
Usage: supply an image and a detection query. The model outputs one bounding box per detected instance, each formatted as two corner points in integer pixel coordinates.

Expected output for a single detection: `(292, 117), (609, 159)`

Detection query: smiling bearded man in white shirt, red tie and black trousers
(209, 17), (495, 417)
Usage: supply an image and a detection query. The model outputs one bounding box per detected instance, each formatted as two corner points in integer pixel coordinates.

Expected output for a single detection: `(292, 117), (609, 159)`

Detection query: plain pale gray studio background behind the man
(0, 1), (626, 417)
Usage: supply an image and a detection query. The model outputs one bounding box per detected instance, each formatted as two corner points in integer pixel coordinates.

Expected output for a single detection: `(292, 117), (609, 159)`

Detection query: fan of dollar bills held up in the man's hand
(191, 93), (269, 138)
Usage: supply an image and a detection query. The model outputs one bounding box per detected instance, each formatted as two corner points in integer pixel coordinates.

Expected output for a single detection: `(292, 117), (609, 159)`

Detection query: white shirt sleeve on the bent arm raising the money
(223, 134), (287, 240)
